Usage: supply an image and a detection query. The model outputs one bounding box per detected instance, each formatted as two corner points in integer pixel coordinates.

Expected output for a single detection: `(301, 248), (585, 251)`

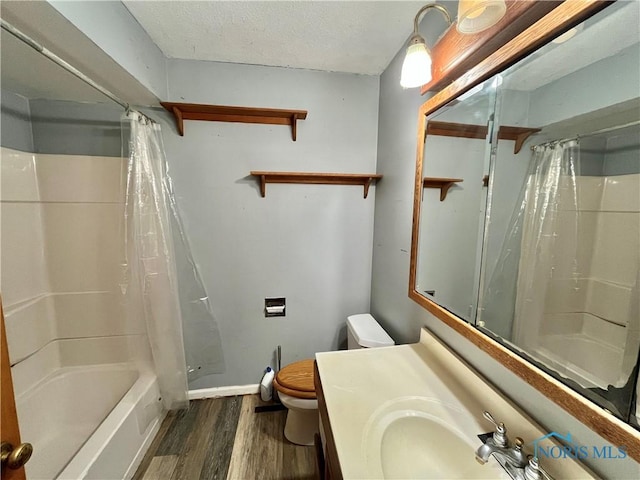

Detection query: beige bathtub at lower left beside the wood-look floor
(14, 337), (164, 480)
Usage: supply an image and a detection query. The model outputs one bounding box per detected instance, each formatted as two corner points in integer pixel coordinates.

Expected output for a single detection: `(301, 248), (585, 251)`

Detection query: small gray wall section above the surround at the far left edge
(0, 90), (33, 152)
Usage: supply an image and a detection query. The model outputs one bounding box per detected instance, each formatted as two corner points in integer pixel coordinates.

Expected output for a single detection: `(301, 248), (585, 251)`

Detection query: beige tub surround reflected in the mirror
(513, 157), (640, 394)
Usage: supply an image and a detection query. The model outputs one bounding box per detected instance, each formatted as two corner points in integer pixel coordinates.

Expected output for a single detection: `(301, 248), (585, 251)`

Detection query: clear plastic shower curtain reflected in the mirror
(481, 139), (585, 349)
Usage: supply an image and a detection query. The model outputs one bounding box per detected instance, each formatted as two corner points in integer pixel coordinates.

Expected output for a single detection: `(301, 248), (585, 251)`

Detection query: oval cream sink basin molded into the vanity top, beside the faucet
(363, 397), (508, 479)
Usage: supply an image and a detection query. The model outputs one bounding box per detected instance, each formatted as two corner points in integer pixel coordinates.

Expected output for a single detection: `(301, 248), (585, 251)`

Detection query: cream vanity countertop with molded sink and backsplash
(316, 329), (597, 480)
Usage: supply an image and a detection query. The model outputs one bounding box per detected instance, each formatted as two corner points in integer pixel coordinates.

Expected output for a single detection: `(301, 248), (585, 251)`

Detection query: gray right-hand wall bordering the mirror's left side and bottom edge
(371, 15), (639, 478)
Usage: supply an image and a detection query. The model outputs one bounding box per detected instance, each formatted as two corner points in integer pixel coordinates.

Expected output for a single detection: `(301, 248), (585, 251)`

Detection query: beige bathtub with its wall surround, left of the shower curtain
(0, 144), (162, 478)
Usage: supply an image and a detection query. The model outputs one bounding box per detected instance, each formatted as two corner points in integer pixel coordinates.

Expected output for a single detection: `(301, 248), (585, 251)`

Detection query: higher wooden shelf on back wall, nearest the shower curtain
(160, 102), (307, 142)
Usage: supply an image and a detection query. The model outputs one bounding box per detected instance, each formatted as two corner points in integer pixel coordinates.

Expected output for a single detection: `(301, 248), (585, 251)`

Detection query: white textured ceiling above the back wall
(123, 0), (440, 75)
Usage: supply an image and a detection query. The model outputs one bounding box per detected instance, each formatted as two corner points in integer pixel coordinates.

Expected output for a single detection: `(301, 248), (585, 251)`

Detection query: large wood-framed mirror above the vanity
(410, 2), (640, 450)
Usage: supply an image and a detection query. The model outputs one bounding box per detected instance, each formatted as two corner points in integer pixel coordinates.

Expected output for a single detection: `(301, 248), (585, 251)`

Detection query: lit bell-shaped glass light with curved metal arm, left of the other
(400, 3), (451, 88)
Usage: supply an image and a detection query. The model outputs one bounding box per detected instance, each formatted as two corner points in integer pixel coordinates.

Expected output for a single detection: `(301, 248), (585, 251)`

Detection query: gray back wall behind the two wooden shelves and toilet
(162, 60), (386, 389)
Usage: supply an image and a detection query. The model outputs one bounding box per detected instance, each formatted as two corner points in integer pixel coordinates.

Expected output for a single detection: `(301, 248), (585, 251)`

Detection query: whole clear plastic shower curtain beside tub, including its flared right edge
(121, 111), (225, 409)
